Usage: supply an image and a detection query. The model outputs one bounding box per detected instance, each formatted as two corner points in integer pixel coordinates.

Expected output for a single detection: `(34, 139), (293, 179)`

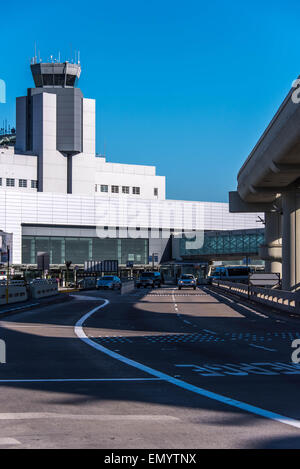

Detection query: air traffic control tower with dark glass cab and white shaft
(16, 58), (95, 194)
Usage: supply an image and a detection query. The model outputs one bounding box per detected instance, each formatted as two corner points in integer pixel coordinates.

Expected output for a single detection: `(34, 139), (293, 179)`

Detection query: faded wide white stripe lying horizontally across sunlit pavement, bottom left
(0, 412), (180, 422)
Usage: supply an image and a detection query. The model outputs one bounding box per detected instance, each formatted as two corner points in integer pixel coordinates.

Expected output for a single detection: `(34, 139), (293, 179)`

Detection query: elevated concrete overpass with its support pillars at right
(229, 80), (300, 290)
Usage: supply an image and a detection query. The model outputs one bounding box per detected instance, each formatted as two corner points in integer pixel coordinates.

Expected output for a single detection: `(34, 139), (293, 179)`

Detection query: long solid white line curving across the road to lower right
(74, 298), (300, 428)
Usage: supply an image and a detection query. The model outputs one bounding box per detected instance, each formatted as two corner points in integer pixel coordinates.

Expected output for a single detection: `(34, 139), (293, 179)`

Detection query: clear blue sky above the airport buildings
(0, 0), (300, 202)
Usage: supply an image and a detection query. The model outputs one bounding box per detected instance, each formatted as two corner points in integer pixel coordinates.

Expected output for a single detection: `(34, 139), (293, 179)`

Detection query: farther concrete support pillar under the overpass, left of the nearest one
(259, 212), (282, 276)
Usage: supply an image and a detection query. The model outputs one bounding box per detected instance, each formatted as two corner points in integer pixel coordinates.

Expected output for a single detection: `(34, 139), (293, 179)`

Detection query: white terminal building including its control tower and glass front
(0, 59), (263, 274)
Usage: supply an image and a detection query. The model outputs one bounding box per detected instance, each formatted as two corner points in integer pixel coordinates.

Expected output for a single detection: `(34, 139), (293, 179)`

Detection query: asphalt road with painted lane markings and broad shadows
(0, 286), (300, 449)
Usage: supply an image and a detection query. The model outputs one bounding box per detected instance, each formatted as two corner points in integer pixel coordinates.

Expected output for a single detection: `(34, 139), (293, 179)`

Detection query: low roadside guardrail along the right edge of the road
(211, 280), (300, 314)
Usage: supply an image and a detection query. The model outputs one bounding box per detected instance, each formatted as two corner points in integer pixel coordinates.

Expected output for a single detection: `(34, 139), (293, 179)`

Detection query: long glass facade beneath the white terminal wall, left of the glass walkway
(22, 236), (149, 265)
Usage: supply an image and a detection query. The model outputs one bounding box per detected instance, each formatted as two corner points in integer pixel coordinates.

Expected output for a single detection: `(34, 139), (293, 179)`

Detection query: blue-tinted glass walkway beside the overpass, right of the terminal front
(179, 229), (264, 257)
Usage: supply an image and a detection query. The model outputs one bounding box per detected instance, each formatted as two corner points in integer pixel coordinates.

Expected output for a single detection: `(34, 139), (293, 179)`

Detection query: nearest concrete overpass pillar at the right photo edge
(282, 189), (300, 291)
